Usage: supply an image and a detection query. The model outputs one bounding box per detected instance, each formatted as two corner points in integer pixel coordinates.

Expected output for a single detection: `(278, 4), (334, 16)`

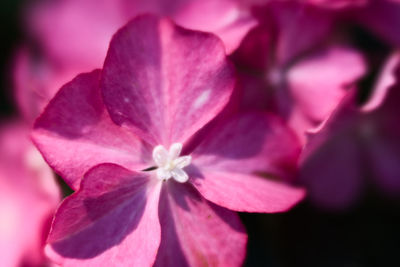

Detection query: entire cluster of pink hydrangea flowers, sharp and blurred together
(0, 0), (400, 267)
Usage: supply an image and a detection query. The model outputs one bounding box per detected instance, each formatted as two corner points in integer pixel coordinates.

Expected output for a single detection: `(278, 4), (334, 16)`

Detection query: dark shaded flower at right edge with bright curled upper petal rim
(301, 54), (400, 209)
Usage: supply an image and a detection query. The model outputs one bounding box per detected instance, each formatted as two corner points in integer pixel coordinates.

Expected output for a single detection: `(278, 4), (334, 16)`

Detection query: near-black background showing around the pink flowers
(0, 0), (400, 267)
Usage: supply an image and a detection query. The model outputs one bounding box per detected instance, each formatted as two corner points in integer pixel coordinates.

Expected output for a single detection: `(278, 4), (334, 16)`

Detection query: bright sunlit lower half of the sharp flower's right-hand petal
(191, 170), (305, 213)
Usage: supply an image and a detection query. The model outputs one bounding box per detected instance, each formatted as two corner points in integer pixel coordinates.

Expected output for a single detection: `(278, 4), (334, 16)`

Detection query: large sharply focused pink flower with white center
(33, 16), (304, 266)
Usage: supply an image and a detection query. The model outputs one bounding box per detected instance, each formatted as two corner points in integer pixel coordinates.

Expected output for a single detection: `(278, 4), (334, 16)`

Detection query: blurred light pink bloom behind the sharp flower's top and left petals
(15, 0), (256, 120)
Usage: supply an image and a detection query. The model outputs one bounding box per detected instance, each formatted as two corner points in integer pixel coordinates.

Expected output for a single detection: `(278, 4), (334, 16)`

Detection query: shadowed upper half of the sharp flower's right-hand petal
(192, 112), (300, 177)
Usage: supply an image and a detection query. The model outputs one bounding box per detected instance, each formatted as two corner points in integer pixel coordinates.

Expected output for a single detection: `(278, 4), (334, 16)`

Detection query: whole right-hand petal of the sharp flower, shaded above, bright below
(189, 113), (304, 212)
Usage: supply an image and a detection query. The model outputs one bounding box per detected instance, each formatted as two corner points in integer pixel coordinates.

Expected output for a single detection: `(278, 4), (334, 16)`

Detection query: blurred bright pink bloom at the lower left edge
(0, 122), (60, 267)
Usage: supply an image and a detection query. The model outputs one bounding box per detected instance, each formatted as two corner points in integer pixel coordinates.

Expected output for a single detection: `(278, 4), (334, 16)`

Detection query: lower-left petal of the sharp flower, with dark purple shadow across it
(47, 164), (161, 266)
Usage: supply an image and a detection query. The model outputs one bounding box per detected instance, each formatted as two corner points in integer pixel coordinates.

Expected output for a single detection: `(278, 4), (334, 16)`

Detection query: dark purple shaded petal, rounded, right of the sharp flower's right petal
(300, 132), (364, 209)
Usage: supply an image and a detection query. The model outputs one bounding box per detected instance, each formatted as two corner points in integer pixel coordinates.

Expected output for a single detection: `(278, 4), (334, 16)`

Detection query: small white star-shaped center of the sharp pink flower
(153, 143), (192, 183)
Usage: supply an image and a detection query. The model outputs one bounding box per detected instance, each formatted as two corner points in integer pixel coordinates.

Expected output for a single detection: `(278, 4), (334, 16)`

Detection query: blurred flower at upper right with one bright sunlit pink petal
(234, 2), (366, 141)
